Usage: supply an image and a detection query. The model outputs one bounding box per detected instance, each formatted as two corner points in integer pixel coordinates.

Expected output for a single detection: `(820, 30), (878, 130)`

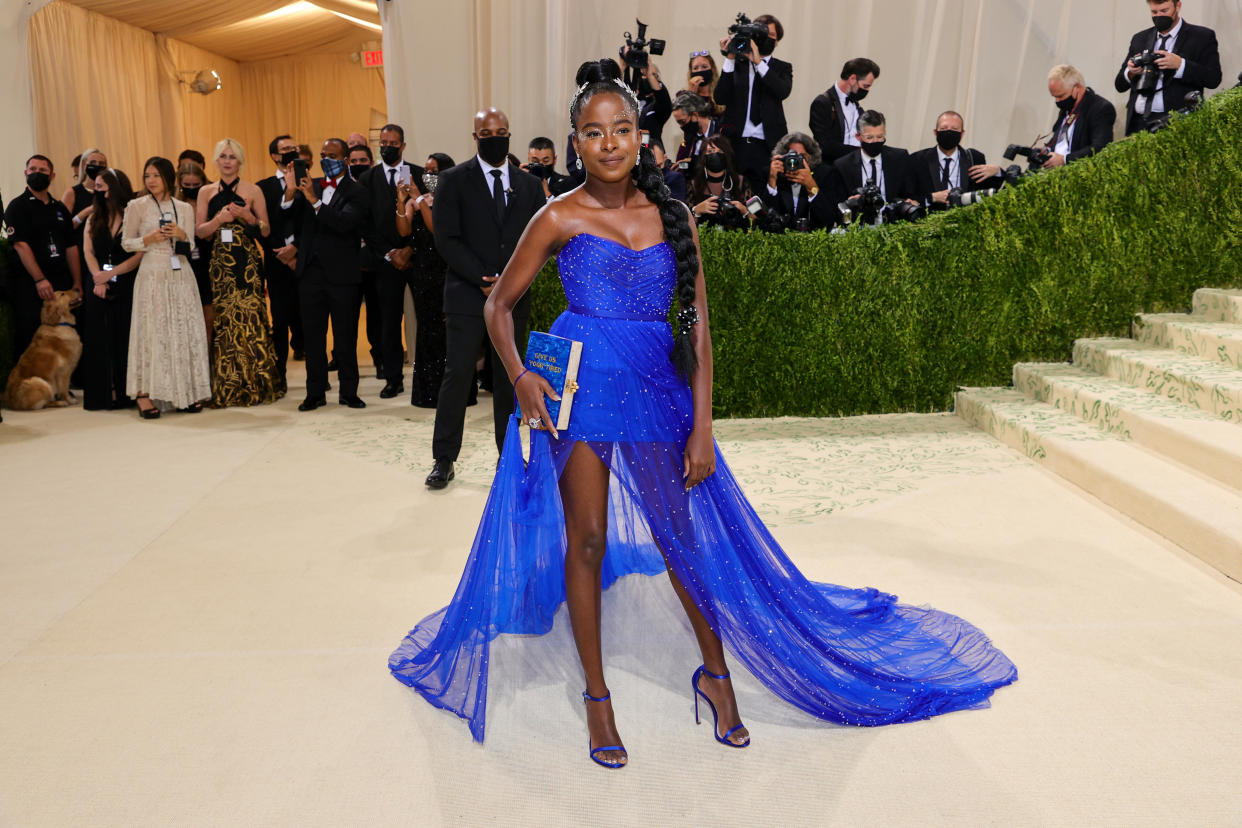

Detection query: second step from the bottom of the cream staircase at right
(1013, 362), (1242, 492)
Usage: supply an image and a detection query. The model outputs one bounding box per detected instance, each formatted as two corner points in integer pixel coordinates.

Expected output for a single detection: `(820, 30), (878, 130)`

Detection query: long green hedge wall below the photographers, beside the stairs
(532, 92), (1242, 417)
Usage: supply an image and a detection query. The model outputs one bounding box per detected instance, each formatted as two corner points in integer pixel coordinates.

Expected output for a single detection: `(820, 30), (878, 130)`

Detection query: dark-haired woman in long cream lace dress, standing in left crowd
(122, 158), (211, 420)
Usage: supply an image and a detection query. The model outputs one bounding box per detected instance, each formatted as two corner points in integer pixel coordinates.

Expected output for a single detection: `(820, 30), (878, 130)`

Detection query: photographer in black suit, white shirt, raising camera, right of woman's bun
(714, 15), (794, 192)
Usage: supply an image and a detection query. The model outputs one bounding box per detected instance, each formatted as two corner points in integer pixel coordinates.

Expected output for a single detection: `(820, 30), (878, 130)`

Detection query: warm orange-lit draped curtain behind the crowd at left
(22, 0), (386, 197)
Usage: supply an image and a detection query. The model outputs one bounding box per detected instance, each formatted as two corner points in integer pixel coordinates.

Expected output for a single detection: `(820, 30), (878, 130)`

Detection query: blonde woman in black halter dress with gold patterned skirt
(197, 138), (286, 408)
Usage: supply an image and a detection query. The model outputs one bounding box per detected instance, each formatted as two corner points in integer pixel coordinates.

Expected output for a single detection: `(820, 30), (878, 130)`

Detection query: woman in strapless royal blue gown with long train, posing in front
(389, 60), (1017, 767)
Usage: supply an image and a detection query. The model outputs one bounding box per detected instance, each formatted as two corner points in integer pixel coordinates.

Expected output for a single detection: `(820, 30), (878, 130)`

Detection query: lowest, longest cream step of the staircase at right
(955, 389), (1242, 581)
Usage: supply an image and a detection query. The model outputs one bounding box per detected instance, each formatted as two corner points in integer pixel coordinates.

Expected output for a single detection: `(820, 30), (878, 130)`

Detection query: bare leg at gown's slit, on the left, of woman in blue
(560, 443), (626, 762)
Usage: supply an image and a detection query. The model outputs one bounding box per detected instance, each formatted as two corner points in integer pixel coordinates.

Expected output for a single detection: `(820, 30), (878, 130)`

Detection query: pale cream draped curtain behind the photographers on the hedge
(379, 0), (1242, 171)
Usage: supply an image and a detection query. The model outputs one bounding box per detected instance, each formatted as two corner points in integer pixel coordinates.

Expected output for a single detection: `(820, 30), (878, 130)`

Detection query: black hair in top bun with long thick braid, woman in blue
(569, 57), (699, 382)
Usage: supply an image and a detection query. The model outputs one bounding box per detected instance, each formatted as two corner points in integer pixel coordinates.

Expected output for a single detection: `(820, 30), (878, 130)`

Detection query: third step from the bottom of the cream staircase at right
(1074, 338), (1242, 422)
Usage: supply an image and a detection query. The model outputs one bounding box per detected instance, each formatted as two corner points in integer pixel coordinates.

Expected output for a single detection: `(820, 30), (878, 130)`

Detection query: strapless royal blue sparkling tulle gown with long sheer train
(389, 233), (1017, 741)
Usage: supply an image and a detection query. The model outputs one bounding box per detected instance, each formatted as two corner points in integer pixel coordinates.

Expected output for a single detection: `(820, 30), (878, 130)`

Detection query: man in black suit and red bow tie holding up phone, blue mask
(281, 138), (369, 411)
